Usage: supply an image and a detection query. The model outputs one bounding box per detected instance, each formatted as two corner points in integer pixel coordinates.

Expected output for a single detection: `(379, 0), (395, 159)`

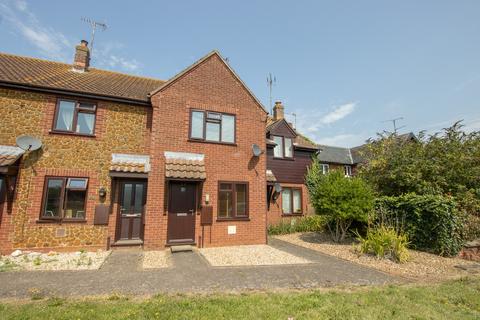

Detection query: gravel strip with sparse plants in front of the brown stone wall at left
(0, 250), (110, 271)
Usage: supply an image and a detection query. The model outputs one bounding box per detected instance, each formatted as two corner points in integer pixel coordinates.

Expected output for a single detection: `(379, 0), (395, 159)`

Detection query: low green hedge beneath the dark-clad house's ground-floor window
(268, 216), (326, 235)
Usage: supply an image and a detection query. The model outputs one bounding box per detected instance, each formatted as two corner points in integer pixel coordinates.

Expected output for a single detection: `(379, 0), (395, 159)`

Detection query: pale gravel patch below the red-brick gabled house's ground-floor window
(199, 245), (311, 267)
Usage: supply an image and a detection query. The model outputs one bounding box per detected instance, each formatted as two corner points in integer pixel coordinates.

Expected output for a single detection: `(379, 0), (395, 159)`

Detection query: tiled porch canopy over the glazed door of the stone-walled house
(110, 153), (150, 178)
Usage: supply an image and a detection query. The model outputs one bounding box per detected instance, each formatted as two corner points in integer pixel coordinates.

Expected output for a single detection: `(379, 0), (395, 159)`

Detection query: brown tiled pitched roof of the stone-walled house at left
(0, 53), (165, 103)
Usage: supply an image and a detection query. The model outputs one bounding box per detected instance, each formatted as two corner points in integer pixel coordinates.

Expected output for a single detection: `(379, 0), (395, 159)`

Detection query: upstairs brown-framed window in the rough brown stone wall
(54, 100), (97, 135)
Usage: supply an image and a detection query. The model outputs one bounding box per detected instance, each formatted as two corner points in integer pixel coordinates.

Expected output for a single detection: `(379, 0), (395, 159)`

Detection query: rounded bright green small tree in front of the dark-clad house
(306, 159), (374, 242)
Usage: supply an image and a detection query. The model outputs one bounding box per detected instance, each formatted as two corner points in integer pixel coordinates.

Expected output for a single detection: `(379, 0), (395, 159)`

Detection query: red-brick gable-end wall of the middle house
(145, 55), (266, 248)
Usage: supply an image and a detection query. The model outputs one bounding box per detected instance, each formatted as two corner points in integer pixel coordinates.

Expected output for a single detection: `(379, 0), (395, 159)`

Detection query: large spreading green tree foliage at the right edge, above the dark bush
(359, 122), (480, 215)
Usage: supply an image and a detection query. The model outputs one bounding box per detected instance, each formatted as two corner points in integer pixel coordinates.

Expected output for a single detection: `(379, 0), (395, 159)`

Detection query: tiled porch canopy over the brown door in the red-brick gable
(165, 151), (207, 181)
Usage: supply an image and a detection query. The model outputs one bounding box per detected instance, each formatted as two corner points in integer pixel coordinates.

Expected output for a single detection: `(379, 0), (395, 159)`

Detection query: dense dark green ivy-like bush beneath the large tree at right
(375, 193), (464, 256)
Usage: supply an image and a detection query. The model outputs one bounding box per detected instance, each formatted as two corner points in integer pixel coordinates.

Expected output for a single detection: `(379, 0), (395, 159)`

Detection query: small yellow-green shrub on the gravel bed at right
(357, 226), (409, 263)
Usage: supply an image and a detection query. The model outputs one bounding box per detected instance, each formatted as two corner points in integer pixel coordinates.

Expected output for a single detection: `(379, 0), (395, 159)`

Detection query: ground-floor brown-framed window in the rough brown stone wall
(40, 177), (88, 220)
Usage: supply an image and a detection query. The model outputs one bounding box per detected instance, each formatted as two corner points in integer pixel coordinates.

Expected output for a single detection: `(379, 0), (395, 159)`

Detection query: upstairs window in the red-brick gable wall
(190, 110), (235, 143)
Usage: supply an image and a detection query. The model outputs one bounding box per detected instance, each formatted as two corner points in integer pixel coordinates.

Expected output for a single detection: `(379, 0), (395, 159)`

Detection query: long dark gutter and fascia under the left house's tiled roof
(0, 80), (152, 107)
